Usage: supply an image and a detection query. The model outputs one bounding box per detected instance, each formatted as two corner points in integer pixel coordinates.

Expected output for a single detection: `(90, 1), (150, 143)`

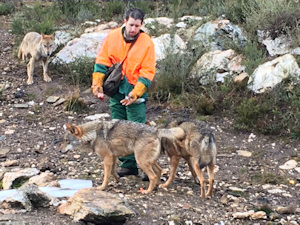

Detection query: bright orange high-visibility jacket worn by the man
(94, 27), (155, 85)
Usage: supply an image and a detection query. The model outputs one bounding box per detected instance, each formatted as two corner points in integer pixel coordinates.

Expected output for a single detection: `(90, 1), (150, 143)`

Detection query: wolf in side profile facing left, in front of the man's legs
(60, 119), (185, 194)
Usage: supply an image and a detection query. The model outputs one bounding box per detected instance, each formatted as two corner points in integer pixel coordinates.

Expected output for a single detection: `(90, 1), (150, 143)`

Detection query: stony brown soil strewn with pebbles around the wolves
(0, 14), (300, 225)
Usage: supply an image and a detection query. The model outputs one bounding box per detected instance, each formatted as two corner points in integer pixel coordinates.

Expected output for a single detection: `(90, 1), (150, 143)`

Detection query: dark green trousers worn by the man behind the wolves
(109, 93), (146, 169)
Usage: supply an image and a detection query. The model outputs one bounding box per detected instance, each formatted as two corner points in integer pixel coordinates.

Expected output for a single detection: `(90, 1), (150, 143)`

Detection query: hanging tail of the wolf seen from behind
(199, 133), (217, 169)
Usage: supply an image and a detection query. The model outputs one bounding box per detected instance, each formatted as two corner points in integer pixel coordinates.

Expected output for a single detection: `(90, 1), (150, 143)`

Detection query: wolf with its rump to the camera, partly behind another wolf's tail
(159, 121), (217, 197)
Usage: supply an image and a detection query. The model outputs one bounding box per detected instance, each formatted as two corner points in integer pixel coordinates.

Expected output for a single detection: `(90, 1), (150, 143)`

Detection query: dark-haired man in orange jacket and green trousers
(92, 8), (155, 180)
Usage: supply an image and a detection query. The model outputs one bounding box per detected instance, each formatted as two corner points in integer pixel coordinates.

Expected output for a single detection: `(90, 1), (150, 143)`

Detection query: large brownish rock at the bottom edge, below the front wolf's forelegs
(57, 188), (134, 224)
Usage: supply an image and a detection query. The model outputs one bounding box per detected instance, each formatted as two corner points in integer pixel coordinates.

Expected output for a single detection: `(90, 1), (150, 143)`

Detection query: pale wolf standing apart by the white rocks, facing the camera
(18, 32), (56, 85)
